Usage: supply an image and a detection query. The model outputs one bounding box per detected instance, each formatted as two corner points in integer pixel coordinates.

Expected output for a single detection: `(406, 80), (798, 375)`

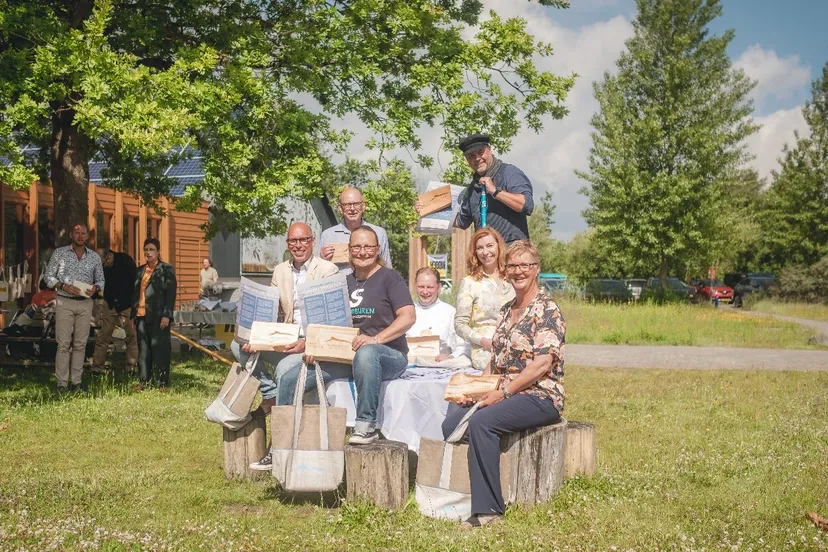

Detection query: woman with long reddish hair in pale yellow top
(454, 228), (515, 370)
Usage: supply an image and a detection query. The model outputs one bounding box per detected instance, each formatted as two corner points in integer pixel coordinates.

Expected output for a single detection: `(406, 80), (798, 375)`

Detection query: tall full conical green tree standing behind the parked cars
(579, 0), (756, 279)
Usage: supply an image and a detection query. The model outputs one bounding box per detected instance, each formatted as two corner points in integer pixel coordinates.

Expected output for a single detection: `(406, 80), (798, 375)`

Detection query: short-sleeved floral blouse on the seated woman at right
(490, 291), (566, 412)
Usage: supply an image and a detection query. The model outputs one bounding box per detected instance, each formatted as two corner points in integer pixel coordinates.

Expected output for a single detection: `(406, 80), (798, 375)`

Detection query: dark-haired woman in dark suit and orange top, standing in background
(131, 238), (177, 391)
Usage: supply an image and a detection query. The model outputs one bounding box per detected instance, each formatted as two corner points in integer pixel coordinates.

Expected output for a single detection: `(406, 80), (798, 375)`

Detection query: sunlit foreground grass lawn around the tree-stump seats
(0, 362), (828, 551)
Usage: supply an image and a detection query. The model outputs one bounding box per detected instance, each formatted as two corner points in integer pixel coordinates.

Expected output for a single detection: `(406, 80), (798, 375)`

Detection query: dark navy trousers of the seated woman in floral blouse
(443, 393), (561, 515)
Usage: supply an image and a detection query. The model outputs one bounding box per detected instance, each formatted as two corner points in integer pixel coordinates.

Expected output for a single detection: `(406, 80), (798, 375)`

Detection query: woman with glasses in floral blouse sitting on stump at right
(443, 240), (566, 527)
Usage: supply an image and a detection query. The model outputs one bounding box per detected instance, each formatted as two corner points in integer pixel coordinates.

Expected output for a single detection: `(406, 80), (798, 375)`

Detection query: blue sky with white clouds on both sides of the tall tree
(346, 0), (828, 240)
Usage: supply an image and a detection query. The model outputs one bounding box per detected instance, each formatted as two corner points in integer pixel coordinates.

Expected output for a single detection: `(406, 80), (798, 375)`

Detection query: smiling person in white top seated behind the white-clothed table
(405, 266), (471, 362)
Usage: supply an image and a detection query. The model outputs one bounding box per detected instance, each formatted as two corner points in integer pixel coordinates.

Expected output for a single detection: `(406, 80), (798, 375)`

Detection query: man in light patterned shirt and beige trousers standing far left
(45, 224), (105, 393)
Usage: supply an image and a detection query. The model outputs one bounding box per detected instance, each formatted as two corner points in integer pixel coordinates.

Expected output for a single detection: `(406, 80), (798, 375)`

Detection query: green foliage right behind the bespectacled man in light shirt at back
(322, 159), (417, 277)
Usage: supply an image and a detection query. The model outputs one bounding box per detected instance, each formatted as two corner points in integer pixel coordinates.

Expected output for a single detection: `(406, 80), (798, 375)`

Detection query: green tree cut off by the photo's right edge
(759, 63), (828, 270)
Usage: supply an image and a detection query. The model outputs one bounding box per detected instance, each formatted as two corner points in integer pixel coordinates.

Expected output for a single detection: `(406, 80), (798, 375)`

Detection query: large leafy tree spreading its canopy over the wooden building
(0, 0), (574, 243)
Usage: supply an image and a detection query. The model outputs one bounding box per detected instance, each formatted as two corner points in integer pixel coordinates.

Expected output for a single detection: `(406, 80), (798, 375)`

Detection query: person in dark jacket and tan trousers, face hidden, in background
(92, 249), (138, 373)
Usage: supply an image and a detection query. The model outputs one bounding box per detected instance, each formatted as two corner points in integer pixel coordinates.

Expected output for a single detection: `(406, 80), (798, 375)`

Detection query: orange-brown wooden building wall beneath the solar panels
(0, 183), (210, 305)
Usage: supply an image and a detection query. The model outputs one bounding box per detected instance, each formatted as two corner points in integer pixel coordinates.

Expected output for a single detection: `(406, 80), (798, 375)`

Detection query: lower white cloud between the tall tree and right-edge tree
(747, 106), (808, 177)
